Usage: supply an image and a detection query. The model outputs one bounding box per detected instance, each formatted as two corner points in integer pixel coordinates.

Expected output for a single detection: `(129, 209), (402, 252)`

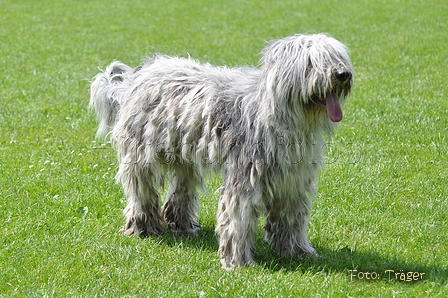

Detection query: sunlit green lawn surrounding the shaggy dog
(0, 0), (448, 297)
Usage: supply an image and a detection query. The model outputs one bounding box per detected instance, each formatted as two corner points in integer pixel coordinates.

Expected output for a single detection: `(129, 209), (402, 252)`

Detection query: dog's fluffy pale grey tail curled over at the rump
(90, 61), (133, 137)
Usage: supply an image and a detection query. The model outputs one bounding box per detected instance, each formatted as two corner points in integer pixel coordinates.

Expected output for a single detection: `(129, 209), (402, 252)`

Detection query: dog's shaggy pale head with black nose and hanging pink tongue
(261, 34), (353, 122)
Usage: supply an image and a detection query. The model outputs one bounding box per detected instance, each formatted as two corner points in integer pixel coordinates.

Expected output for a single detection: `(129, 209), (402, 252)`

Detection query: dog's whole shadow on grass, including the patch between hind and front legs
(151, 226), (448, 285)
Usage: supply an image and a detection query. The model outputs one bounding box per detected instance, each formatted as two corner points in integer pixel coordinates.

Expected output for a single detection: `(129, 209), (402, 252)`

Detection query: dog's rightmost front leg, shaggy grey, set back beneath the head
(264, 195), (316, 257)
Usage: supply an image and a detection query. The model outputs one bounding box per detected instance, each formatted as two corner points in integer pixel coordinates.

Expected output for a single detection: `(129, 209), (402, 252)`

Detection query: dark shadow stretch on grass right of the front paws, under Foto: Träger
(256, 247), (448, 285)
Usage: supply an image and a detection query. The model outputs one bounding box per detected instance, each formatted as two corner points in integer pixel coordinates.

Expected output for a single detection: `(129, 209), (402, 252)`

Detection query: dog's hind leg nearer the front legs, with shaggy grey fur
(162, 164), (202, 236)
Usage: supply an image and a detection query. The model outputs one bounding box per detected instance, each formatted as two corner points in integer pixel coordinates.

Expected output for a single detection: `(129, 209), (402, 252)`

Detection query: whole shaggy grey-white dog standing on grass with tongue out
(90, 34), (352, 269)
